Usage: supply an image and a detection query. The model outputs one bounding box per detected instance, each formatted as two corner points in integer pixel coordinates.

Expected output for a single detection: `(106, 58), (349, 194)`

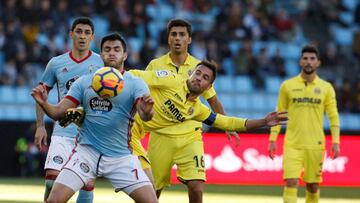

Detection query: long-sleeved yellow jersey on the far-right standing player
(270, 75), (340, 149)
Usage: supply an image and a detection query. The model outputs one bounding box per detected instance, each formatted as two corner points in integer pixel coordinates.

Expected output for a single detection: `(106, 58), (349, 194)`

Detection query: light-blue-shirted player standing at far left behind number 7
(34, 17), (103, 203)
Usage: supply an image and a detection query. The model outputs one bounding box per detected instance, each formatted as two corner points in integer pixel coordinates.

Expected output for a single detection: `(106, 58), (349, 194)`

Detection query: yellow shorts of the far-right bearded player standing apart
(283, 147), (325, 183)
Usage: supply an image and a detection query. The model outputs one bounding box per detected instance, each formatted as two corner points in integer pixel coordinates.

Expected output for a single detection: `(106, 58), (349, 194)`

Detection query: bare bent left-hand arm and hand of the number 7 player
(31, 85), (77, 120)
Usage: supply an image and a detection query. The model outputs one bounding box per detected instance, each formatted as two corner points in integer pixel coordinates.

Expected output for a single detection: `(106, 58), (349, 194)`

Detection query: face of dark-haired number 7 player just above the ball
(101, 40), (127, 69)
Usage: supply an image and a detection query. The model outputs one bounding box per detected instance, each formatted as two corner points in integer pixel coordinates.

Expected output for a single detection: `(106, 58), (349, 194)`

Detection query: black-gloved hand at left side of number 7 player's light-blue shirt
(59, 107), (85, 127)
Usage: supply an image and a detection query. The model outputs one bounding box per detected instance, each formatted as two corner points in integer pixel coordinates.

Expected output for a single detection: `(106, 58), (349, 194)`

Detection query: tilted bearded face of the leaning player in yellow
(187, 65), (213, 94)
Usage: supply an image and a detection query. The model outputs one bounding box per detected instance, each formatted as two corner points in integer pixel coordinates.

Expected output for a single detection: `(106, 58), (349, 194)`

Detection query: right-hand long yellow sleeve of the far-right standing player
(324, 84), (340, 144)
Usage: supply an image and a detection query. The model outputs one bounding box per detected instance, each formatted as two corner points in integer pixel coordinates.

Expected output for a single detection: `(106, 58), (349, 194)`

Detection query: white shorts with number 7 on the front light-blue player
(56, 145), (152, 194)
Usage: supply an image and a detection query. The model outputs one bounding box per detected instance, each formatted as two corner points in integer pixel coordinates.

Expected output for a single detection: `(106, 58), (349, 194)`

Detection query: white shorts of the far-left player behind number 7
(44, 136), (76, 171)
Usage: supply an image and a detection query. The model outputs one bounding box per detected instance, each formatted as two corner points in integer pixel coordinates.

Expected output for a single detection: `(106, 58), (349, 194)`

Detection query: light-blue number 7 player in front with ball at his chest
(32, 31), (157, 203)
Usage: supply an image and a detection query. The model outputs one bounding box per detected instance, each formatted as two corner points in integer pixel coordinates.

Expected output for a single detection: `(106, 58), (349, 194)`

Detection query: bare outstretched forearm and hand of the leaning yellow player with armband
(245, 112), (288, 130)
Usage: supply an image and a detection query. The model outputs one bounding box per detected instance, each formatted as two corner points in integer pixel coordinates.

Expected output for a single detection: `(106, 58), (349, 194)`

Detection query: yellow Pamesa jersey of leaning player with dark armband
(129, 70), (246, 132)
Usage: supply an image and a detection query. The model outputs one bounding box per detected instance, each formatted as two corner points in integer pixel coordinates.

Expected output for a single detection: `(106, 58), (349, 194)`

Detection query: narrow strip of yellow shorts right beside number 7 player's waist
(130, 114), (151, 169)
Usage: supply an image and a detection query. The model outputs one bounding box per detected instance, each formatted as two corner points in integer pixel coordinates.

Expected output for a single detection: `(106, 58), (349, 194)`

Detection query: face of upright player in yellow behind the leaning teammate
(168, 27), (191, 54)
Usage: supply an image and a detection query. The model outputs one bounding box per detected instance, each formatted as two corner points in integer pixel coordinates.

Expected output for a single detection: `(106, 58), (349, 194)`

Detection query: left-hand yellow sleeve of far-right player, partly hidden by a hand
(269, 83), (288, 141)
